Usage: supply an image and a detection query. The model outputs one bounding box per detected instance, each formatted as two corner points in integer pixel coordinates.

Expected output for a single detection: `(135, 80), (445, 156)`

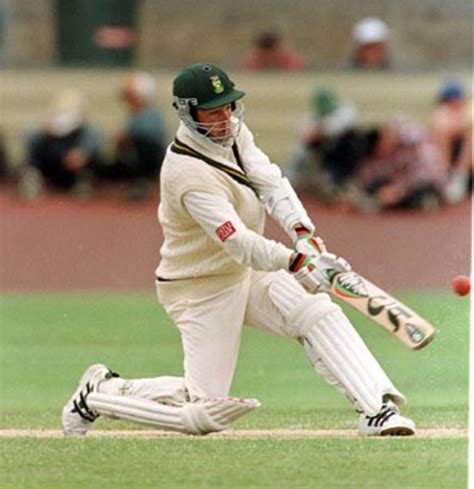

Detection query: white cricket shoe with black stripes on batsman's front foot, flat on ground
(359, 402), (415, 436)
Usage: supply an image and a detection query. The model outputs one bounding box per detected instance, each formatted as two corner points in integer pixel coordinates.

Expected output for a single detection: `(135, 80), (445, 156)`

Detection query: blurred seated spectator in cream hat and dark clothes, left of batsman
(17, 90), (102, 198)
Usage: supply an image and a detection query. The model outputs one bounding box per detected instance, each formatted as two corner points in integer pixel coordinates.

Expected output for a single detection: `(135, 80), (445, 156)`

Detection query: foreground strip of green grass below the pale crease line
(2, 439), (467, 489)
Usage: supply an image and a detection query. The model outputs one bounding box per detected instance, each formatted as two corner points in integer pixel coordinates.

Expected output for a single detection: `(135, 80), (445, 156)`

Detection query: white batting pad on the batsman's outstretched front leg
(270, 275), (406, 416)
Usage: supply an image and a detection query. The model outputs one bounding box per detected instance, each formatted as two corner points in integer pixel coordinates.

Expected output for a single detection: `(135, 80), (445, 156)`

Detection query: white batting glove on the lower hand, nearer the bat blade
(289, 251), (352, 294)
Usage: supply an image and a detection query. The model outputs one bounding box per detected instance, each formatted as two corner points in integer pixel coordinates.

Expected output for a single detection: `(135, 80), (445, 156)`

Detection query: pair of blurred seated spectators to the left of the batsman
(9, 72), (168, 200)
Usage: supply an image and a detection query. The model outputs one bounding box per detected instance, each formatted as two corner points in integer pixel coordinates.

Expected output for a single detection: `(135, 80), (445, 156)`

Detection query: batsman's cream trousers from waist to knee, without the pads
(158, 271), (300, 400)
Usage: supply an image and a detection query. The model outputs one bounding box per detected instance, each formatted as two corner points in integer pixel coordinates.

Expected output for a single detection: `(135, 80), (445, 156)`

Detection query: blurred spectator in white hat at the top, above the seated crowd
(351, 17), (392, 70)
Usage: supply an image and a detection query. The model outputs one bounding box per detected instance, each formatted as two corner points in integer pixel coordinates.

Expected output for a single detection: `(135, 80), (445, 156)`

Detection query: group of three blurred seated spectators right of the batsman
(287, 81), (473, 210)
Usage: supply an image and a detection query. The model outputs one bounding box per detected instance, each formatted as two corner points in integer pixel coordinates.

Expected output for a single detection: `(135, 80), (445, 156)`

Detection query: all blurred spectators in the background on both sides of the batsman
(0, 18), (473, 210)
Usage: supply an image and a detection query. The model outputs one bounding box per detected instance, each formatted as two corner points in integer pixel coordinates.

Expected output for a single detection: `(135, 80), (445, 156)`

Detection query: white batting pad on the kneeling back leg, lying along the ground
(87, 393), (260, 435)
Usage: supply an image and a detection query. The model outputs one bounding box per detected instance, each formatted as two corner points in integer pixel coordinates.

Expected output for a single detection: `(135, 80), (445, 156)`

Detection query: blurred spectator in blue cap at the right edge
(431, 81), (473, 204)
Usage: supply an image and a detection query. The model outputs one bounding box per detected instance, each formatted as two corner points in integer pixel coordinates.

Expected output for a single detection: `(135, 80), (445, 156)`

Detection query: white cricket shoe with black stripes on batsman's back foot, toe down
(61, 364), (119, 436)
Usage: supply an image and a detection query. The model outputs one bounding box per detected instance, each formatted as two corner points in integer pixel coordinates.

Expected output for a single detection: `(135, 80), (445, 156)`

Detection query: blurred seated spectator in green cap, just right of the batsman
(287, 88), (365, 201)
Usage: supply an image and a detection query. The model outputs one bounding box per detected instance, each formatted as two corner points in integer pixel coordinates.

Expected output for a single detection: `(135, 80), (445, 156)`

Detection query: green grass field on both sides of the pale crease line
(0, 292), (469, 489)
